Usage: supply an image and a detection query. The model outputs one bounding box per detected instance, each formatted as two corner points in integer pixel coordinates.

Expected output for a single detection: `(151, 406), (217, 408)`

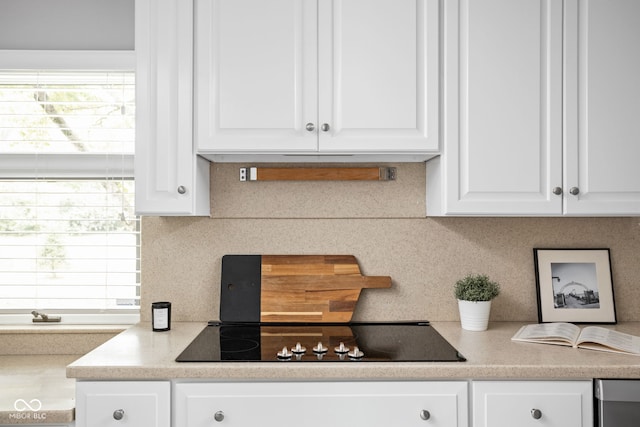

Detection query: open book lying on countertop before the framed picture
(511, 323), (640, 356)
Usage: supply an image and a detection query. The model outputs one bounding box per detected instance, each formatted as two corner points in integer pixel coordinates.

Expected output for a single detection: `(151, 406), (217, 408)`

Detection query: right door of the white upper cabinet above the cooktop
(318, 0), (439, 152)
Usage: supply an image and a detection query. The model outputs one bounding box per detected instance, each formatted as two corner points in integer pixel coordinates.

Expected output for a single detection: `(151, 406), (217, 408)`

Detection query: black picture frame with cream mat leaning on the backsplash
(533, 248), (617, 324)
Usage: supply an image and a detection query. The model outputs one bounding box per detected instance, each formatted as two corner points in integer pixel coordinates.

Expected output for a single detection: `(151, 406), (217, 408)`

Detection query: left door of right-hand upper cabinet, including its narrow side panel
(427, 0), (562, 215)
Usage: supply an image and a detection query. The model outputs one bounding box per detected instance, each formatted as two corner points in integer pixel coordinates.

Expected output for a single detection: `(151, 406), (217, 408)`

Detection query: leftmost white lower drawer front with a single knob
(76, 381), (171, 427)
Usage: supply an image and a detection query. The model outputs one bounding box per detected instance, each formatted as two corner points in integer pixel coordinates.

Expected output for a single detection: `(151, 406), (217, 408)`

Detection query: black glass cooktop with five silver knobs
(176, 322), (466, 363)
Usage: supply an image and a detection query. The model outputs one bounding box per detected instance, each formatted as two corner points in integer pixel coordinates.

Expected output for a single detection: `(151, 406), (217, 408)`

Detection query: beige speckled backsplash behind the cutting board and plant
(141, 163), (640, 321)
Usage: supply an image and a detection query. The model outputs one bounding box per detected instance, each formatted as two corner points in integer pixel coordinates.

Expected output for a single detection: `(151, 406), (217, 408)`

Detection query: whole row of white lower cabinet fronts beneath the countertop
(75, 380), (594, 427)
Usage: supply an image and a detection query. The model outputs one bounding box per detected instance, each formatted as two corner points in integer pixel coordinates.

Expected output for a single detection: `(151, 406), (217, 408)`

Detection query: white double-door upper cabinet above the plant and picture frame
(427, 0), (640, 216)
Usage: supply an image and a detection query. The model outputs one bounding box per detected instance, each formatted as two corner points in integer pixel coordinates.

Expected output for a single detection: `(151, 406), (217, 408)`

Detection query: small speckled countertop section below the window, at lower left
(0, 355), (78, 425)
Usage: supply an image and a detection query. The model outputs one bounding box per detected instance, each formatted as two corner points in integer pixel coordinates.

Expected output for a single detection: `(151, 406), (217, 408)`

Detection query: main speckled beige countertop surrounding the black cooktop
(67, 322), (640, 380)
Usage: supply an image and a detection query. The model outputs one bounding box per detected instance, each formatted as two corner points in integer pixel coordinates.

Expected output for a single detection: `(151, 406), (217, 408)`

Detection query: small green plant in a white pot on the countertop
(454, 274), (500, 331)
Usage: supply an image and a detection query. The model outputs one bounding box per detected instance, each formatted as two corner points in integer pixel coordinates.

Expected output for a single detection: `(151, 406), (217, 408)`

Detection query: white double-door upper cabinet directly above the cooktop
(195, 0), (438, 160)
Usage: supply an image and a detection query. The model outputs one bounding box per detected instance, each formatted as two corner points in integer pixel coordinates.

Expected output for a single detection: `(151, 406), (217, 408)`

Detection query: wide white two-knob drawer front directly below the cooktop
(173, 381), (468, 427)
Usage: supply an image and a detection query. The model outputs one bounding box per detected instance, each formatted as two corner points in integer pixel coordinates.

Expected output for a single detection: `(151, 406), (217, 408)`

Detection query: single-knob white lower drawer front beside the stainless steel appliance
(472, 381), (593, 427)
